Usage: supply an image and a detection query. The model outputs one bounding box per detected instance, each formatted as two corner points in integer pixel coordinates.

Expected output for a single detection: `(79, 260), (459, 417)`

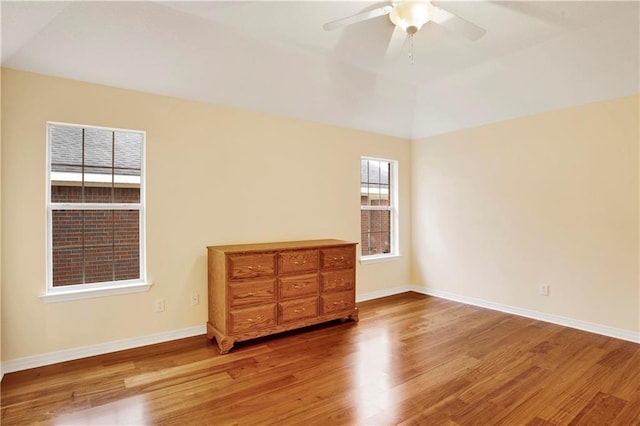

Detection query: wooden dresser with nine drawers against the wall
(207, 240), (358, 354)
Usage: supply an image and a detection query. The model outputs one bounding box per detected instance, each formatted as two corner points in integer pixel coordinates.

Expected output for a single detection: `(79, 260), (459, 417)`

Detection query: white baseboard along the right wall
(410, 286), (640, 343)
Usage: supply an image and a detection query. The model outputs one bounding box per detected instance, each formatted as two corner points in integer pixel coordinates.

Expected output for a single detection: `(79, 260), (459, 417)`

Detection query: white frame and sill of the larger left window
(40, 121), (152, 303)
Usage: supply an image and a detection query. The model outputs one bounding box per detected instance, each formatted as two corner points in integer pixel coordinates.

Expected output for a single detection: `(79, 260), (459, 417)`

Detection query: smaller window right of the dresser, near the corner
(360, 157), (398, 259)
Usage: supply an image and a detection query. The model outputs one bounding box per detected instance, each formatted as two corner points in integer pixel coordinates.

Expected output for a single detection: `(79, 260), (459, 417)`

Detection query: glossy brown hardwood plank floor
(1, 293), (640, 425)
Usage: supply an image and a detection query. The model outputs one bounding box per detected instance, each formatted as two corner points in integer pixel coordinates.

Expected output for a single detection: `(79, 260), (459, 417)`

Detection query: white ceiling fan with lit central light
(322, 0), (487, 63)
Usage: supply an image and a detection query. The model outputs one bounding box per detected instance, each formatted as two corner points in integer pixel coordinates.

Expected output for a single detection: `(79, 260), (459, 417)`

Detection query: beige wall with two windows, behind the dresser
(2, 69), (411, 360)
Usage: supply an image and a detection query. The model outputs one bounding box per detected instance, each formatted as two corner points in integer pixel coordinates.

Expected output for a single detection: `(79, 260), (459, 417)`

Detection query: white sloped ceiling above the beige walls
(0, 0), (640, 139)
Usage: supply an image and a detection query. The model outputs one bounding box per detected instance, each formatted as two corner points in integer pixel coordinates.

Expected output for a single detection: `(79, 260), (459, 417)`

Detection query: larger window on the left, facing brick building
(47, 123), (146, 293)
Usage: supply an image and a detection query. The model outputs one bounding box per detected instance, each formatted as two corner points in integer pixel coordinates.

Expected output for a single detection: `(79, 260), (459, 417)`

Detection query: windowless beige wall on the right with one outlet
(412, 96), (640, 332)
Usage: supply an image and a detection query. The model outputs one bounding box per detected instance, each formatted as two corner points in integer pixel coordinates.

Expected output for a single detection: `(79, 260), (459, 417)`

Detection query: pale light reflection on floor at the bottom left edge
(53, 395), (150, 426)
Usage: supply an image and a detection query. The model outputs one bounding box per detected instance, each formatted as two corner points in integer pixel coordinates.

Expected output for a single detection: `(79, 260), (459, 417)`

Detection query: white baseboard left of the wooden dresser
(0, 325), (207, 374)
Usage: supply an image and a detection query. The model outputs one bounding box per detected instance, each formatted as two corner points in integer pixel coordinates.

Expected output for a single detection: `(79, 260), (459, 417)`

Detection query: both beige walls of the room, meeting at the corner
(0, 65), (640, 361)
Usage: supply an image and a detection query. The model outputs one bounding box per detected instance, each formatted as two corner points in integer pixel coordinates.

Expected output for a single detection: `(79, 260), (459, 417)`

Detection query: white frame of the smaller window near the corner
(358, 156), (400, 263)
